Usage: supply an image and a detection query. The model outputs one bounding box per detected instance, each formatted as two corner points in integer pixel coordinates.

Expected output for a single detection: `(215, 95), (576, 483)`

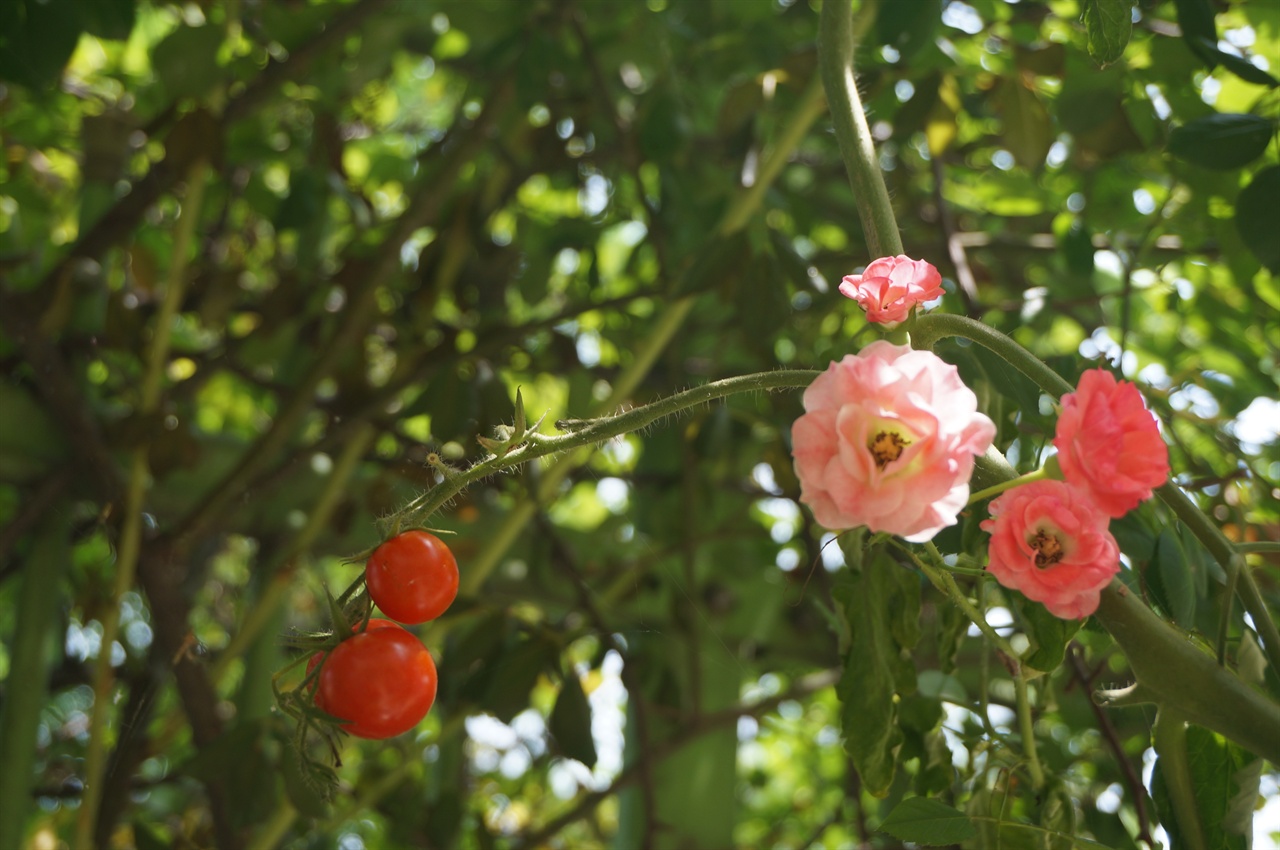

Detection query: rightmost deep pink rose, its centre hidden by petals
(1053, 369), (1169, 517)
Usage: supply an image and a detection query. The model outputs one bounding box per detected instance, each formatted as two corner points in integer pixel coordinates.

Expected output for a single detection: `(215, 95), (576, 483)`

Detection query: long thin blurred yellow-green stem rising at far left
(76, 160), (209, 847)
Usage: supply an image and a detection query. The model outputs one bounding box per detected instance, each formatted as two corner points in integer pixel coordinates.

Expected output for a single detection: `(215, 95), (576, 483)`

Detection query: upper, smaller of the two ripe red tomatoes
(365, 531), (458, 623)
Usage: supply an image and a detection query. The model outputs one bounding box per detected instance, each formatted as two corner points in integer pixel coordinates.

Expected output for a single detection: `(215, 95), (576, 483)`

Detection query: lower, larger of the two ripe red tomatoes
(315, 622), (436, 739)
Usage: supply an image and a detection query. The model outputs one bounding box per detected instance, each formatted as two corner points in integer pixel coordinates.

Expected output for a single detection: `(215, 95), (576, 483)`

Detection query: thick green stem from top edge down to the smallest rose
(818, 0), (902, 257)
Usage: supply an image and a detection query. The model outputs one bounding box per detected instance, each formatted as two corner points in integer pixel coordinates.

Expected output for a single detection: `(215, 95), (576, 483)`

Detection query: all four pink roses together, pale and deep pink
(791, 289), (1169, 618)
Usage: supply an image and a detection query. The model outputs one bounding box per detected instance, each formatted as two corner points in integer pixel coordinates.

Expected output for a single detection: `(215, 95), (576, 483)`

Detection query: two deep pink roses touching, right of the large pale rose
(982, 369), (1169, 620)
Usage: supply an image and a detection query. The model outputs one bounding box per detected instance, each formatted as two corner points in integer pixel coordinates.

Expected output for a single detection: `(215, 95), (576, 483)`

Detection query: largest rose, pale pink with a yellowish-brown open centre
(791, 339), (996, 543)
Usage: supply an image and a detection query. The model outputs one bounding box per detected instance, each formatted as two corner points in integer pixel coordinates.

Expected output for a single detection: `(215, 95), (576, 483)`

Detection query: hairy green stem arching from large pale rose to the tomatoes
(399, 369), (819, 532)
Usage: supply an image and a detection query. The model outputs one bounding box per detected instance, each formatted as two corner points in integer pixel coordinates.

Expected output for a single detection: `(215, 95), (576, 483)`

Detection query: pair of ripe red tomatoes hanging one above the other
(307, 531), (458, 739)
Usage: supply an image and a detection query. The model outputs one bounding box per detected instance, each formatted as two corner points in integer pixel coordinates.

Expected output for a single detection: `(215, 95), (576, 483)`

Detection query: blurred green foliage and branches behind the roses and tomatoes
(0, 0), (1280, 850)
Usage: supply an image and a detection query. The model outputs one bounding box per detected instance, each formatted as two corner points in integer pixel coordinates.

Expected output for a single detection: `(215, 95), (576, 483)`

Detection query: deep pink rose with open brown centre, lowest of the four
(982, 481), (1120, 620)
